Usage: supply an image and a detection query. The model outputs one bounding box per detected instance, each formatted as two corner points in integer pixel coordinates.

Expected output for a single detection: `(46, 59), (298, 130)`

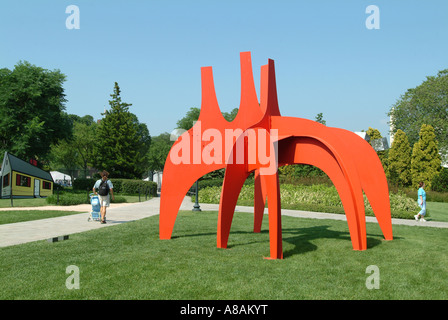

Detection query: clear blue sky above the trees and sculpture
(0, 0), (448, 141)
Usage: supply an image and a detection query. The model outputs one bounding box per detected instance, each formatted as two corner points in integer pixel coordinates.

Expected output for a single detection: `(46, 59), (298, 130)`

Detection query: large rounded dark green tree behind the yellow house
(0, 61), (72, 162)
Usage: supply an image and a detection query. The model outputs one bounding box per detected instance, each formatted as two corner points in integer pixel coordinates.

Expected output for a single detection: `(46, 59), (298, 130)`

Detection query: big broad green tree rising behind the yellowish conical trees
(388, 69), (448, 158)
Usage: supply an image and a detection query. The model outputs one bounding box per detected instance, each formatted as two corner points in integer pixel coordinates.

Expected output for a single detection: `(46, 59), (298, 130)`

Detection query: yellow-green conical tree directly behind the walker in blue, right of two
(411, 124), (442, 189)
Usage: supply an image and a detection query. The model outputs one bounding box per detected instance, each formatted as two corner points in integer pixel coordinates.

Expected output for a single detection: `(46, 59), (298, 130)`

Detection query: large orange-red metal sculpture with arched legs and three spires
(159, 52), (392, 259)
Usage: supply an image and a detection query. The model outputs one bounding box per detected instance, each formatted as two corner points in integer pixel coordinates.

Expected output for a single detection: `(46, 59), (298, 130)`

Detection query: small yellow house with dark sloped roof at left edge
(0, 152), (54, 198)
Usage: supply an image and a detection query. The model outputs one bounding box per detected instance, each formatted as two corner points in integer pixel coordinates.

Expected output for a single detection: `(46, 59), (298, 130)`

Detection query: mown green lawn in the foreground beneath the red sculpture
(0, 211), (448, 300)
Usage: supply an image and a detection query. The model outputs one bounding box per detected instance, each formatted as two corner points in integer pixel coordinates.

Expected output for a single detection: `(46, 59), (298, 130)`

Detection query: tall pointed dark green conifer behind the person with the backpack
(94, 82), (151, 179)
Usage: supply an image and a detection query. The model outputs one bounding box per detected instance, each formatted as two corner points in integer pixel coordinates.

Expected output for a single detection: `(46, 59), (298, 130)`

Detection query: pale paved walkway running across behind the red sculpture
(0, 197), (448, 247)
